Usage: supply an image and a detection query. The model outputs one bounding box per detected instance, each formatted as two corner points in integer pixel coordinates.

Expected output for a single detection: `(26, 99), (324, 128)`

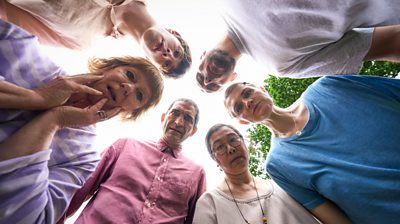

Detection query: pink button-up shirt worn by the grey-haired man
(63, 139), (206, 224)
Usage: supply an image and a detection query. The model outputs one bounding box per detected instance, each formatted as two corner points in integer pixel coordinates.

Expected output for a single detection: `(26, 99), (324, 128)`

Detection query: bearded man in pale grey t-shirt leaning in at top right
(196, 0), (400, 92)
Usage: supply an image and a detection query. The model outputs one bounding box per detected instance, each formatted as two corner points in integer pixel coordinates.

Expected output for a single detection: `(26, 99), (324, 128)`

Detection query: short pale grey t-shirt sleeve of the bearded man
(278, 28), (373, 78)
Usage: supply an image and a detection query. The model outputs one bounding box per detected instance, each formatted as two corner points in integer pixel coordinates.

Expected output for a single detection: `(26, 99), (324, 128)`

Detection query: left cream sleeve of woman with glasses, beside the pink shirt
(193, 193), (218, 224)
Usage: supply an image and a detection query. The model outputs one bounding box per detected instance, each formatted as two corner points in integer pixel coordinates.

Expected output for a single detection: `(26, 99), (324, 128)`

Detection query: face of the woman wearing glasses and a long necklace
(210, 127), (249, 173)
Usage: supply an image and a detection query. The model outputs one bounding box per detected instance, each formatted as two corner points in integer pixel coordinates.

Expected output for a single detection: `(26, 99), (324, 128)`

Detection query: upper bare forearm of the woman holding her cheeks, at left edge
(0, 81), (43, 110)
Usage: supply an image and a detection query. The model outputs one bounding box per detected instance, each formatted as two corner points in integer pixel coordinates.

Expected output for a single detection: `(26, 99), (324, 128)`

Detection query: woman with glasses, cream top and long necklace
(193, 124), (318, 224)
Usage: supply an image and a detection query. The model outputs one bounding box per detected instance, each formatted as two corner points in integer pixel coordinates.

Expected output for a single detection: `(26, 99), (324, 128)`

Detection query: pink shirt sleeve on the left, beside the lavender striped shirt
(58, 142), (119, 223)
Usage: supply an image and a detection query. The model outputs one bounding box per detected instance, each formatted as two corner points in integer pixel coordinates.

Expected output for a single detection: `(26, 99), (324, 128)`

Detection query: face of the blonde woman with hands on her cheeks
(89, 66), (151, 111)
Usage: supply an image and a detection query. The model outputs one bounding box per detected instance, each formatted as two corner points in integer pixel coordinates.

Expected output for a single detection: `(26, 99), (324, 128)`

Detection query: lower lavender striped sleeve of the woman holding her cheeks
(0, 126), (98, 223)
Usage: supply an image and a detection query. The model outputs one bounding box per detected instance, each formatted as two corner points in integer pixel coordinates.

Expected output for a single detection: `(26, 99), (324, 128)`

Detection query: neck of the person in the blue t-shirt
(261, 101), (304, 138)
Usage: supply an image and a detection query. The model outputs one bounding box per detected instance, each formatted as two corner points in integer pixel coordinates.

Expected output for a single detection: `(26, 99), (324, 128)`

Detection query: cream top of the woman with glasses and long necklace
(193, 180), (319, 224)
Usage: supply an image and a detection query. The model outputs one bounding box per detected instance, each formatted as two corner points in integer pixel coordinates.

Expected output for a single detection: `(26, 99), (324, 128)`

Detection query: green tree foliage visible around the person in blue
(247, 61), (400, 178)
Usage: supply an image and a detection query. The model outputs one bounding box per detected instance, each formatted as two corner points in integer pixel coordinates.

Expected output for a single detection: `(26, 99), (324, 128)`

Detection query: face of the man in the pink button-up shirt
(162, 101), (197, 146)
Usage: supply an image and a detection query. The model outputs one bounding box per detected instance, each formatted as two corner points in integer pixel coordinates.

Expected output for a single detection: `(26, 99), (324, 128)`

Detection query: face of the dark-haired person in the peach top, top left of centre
(141, 27), (184, 72)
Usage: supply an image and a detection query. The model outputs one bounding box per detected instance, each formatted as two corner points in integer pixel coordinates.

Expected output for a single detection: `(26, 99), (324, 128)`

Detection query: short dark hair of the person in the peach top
(163, 29), (192, 78)
